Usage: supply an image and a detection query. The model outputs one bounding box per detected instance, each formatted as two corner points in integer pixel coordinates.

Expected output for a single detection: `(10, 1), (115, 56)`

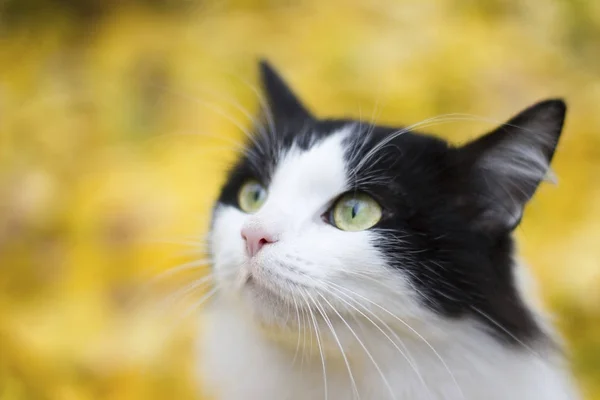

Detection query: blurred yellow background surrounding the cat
(0, 0), (600, 400)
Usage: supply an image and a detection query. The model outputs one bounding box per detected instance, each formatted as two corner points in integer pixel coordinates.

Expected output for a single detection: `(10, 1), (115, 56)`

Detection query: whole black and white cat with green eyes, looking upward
(199, 62), (579, 400)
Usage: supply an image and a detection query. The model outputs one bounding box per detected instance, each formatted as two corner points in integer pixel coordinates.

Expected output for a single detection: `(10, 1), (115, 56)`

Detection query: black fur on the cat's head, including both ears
(219, 62), (566, 344)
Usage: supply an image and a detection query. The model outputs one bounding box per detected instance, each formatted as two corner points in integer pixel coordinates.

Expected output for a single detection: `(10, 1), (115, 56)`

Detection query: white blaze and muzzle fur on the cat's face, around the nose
(211, 127), (412, 322)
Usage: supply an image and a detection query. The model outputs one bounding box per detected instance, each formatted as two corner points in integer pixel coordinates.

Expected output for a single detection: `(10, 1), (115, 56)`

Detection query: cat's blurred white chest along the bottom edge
(198, 304), (576, 400)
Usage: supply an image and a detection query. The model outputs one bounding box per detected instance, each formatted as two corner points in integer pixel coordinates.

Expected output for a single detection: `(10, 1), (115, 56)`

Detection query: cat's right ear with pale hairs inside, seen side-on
(460, 99), (566, 233)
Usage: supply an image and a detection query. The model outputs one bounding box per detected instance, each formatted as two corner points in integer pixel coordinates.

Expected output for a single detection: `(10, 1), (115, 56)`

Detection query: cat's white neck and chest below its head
(199, 299), (576, 400)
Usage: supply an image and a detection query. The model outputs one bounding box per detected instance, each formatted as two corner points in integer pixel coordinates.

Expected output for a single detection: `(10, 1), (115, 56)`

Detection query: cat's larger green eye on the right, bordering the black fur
(331, 193), (381, 232)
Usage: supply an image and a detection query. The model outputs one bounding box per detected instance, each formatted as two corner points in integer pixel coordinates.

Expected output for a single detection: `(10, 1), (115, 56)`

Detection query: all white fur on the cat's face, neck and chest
(198, 126), (577, 400)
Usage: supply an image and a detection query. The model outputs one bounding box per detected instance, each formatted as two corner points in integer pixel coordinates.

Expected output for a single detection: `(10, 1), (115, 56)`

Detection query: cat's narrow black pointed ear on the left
(259, 60), (312, 126)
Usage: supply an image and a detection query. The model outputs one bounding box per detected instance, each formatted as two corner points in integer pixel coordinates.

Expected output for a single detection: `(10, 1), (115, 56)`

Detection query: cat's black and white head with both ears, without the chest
(209, 63), (565, 341)
